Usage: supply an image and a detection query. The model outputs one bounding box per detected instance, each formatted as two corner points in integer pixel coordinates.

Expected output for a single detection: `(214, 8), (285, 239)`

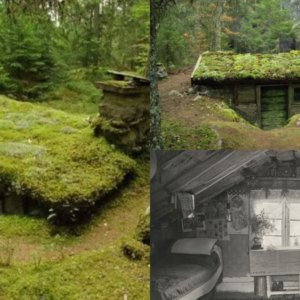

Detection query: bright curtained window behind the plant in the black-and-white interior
(251, 190), (300, 248)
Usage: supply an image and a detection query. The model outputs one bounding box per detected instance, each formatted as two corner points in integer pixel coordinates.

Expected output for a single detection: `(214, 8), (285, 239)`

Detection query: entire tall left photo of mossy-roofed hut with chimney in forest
(0, 0), (150, 300)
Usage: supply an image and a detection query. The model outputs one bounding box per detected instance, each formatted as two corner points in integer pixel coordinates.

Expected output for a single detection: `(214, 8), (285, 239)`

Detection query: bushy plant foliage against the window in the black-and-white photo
(250, 209), (276, 237)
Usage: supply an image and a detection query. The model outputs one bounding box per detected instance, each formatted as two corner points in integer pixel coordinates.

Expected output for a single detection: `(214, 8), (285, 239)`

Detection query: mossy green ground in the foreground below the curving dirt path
(0, 241), (150, 300)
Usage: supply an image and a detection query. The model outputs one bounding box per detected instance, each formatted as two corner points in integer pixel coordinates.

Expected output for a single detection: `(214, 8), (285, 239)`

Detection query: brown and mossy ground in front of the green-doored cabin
(159, 67), (300, 150)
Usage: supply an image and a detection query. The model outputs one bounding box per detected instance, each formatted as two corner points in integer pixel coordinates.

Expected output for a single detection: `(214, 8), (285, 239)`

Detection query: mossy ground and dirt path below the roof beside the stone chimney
(0, 95), (150, 300)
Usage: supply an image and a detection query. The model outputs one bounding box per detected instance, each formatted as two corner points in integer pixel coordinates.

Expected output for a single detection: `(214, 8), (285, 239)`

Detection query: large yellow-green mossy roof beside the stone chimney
(0, 96), (135, 205)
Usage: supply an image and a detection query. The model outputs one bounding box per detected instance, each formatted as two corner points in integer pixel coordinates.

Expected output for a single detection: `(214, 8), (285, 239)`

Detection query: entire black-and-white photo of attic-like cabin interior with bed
(151, 150), (300, 300)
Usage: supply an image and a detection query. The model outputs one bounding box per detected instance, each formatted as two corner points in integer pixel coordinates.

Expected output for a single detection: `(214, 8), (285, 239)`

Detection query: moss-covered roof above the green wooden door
(192, 50), (300, 81)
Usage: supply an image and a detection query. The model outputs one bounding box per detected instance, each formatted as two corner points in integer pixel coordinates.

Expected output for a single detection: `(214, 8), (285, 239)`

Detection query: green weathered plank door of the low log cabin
(261, 86), (288, 130)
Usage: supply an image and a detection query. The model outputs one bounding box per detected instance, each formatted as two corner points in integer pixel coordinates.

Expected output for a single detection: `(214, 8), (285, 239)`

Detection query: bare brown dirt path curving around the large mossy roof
(0, 183), (150, 263)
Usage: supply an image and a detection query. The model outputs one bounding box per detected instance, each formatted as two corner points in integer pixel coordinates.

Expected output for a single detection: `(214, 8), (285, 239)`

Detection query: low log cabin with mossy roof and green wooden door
(191, 51), (300, 130)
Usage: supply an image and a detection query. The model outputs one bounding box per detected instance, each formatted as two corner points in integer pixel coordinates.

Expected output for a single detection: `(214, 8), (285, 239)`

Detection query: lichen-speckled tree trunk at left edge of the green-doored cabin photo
(150, 0), (164, 150)
